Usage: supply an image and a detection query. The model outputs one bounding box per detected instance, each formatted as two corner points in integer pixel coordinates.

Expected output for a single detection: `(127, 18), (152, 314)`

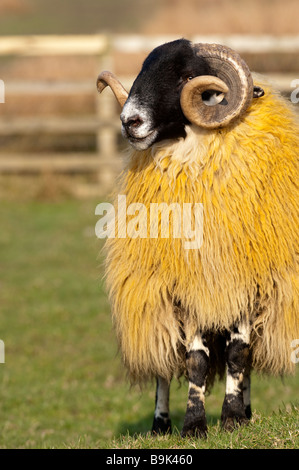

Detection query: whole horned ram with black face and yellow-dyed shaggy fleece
(97, 39), (299, 436)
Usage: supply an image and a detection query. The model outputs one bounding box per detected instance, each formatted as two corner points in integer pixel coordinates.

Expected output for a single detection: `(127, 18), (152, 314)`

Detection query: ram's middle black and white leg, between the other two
(181, 332), (209, 437)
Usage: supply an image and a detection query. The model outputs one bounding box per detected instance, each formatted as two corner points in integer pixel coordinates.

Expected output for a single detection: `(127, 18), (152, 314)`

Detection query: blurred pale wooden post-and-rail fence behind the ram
(0, 35), (299, 189)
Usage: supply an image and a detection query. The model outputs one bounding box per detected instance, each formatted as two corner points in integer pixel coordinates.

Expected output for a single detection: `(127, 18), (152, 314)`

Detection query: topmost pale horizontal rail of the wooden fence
(0, 34), (299, 56)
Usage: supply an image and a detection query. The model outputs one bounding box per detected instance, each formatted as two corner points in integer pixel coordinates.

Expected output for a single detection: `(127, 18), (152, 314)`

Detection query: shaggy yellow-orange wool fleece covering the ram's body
(106, 80), (299, 382)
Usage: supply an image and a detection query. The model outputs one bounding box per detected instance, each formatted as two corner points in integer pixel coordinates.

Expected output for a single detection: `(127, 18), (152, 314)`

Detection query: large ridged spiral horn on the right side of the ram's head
(181, 44), (260, 129)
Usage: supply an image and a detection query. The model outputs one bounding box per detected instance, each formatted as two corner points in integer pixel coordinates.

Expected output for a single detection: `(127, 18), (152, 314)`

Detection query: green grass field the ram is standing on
(0, 200), (299, 449)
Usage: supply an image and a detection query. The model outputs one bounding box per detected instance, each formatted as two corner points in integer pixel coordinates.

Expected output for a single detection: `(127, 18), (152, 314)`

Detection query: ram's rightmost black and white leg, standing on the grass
(221, 319), (250, 431)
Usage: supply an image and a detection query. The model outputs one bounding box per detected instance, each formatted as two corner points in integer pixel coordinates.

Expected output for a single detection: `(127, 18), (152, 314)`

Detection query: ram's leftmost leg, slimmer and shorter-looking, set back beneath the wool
(152, 377), (171, 434)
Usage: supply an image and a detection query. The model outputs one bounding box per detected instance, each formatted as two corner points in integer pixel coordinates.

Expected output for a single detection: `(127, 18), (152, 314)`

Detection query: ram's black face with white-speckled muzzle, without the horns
(120, 39), (209, 150)
